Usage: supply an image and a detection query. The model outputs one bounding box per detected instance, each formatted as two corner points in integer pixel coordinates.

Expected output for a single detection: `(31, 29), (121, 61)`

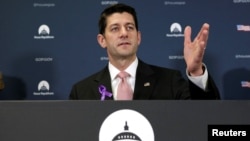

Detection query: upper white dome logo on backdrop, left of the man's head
(34, 24), (55, 39)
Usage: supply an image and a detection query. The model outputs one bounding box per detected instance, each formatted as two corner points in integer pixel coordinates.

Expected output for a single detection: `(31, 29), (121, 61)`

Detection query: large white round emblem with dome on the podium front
(99, 109), (154, 141)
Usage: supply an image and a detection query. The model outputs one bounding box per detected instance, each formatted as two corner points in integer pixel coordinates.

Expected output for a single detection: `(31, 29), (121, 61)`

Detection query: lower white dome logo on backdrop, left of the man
(33, 80), (54, 95)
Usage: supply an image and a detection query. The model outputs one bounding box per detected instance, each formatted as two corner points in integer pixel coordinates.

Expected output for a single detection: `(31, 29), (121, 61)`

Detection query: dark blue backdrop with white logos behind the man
(0, 0), (250, 100)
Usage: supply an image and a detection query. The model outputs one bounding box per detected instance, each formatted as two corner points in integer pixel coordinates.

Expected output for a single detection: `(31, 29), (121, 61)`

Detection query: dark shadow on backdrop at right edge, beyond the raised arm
(223, 68), (250, 100)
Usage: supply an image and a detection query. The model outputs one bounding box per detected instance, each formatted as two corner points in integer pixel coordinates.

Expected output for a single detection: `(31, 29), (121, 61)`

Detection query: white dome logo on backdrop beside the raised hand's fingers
(166, 23), (184, 37)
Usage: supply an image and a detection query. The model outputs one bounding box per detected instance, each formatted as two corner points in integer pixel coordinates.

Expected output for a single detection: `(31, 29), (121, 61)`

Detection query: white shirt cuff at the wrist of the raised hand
(186, 64), (208, 90)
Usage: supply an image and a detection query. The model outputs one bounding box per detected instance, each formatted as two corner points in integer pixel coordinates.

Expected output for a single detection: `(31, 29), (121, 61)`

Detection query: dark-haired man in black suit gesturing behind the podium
(69, 4), (220, 100)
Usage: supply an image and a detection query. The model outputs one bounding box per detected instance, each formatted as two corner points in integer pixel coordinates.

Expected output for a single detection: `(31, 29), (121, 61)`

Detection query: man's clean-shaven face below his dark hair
(98, 12), (141, 59)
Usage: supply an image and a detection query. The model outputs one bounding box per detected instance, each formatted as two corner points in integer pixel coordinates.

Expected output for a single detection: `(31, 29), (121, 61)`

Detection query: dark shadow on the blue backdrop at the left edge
(0, 74), (26, 100)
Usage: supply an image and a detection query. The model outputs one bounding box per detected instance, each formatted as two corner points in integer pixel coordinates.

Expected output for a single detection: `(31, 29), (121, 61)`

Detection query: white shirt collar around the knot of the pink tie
(108, 57), (138, 81)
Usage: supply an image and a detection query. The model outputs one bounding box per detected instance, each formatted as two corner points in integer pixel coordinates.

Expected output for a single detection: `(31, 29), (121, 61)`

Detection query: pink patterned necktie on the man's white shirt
(117, 71), (133, 100)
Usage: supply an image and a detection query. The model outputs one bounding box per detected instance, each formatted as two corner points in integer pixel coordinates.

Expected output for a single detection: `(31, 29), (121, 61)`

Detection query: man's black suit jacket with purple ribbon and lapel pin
(69, 60), (220, 100)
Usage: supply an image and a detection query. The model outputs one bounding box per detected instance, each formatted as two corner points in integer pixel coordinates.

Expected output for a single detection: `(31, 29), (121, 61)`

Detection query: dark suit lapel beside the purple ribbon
(94, 66), (113, 100)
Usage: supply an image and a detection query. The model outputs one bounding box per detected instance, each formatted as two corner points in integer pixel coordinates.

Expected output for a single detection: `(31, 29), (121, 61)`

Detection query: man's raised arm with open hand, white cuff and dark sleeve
(184, 23), (220, 99)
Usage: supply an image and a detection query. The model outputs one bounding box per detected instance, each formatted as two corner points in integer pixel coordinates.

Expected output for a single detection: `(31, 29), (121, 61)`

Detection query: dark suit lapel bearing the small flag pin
(134, 60), (156, 99)
